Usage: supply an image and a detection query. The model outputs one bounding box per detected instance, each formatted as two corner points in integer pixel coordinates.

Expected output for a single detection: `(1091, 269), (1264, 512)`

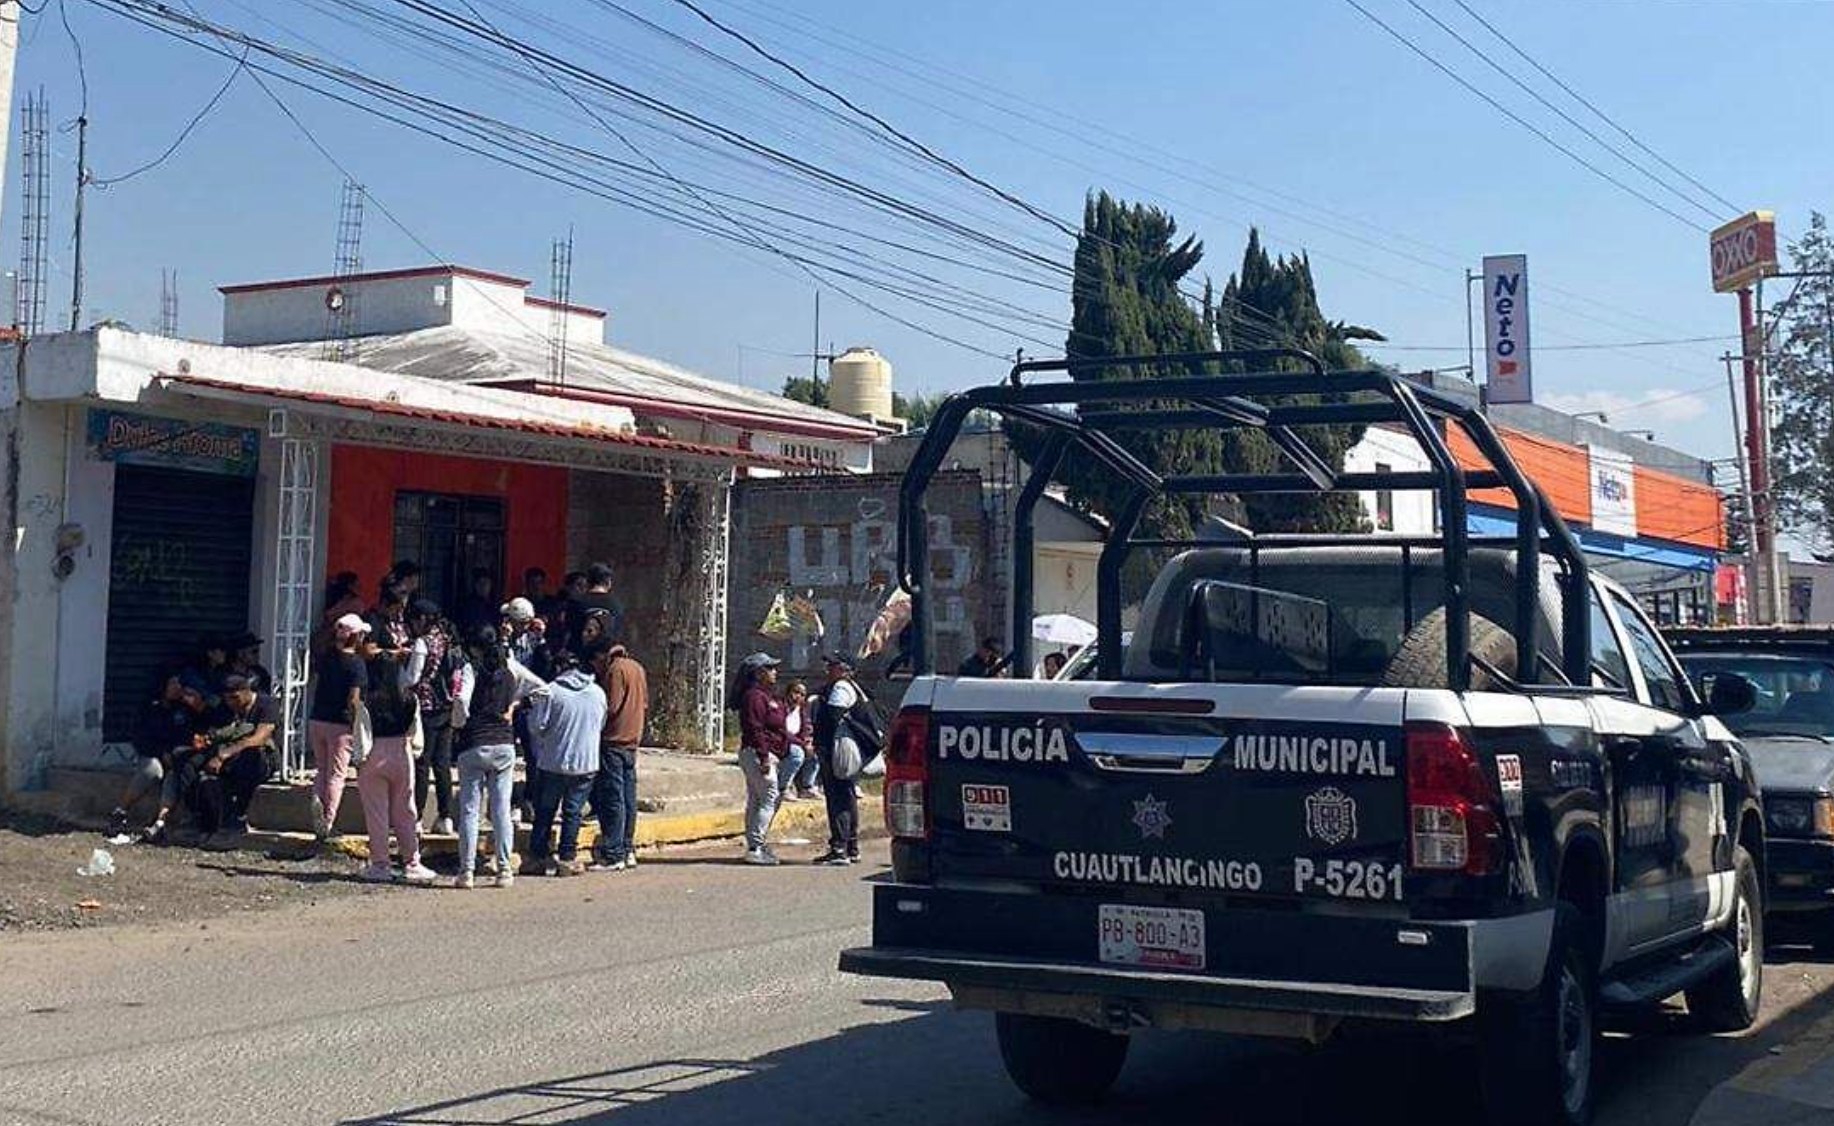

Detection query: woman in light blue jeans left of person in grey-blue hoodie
(451, 625), (541, 888)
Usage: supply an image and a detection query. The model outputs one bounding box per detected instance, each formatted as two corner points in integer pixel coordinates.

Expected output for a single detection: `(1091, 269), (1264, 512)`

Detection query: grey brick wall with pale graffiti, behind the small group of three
(726, 471), (1007, 704)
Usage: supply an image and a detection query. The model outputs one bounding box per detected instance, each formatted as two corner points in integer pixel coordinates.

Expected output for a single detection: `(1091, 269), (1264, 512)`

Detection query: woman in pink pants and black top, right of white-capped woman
(356, 642), (435, 884)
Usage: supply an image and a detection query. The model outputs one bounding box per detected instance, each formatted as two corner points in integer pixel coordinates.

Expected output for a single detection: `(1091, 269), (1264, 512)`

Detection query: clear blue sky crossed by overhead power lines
(4, 0), (1834, 467)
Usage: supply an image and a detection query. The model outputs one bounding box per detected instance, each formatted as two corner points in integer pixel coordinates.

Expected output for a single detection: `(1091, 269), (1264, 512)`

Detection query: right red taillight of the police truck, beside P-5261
(1407, 723), (1502, 877)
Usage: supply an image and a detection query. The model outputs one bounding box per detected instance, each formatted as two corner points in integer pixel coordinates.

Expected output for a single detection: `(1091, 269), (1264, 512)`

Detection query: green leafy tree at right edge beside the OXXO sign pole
(1770, 213), (1834, 552)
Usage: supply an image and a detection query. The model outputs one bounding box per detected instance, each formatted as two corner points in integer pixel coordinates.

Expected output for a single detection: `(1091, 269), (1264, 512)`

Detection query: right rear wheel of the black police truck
(1478, 902), (1597, 1126)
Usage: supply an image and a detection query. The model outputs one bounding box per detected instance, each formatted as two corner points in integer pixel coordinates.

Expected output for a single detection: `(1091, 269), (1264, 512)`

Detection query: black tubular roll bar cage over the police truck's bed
(897, 348), (1592, 691)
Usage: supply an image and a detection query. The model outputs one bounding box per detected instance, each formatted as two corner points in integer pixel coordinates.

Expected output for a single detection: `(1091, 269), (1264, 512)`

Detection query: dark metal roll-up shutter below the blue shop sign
(103, 464), (255, 741)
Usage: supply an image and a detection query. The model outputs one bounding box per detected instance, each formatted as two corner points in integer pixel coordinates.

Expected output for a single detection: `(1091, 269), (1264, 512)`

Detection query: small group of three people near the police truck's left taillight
(726, 653), (884, 866)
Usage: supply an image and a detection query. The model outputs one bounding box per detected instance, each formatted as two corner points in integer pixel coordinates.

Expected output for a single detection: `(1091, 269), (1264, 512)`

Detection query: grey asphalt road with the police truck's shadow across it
(0, 845), (1834, 1126)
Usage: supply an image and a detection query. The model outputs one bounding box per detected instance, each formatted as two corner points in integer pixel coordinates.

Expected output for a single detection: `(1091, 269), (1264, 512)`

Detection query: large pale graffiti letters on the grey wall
(785, 497), (974, 669)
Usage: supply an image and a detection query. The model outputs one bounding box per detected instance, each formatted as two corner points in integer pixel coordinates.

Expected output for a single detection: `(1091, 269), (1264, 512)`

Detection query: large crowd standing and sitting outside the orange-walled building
(116, 561), (649, 888)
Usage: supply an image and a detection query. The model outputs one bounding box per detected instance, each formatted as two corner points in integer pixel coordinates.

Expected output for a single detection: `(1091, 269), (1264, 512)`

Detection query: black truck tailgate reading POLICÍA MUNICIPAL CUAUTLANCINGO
(930, 680), (1407, 909)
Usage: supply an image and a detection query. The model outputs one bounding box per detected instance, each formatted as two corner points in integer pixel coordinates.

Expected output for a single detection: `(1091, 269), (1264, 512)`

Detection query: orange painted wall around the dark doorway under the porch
(326, 446), (567, 598)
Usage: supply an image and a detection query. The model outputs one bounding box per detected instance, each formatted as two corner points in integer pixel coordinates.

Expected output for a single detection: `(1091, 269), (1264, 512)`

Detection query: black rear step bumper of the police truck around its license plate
(840, 884), (1476, 1021)
